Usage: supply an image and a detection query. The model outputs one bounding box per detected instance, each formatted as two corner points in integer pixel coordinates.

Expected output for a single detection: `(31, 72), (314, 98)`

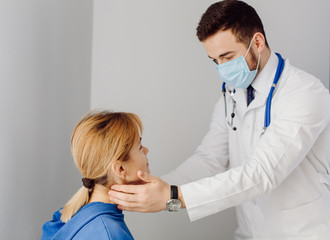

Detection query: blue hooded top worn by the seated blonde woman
(41, 202), (133, 240)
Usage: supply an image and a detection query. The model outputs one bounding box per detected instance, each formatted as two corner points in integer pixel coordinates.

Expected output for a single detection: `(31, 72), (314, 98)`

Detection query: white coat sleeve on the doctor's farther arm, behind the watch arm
(161, 96), (228, 185)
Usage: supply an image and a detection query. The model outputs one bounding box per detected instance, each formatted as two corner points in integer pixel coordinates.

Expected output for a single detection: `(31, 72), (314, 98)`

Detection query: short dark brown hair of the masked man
(197, 0), (268, 47)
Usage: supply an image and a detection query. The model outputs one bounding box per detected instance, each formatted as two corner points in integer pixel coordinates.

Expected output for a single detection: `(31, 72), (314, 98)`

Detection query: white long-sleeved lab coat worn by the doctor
(162, 52), (330, 240)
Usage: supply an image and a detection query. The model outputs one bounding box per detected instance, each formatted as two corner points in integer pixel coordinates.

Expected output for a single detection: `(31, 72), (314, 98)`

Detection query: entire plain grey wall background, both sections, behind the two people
(0, 0), (330, 240)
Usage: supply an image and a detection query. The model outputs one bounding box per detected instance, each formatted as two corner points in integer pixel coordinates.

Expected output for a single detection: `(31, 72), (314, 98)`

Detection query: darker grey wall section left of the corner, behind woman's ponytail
(0, 0), (93, 240)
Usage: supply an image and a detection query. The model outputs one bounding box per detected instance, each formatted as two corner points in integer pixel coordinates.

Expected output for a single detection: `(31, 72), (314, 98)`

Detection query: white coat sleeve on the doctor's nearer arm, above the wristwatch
(181, 71), (330, 221)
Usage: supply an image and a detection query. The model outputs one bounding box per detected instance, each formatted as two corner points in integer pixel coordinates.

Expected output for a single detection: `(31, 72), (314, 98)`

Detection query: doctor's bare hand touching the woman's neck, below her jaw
(108, 171), (170, 212)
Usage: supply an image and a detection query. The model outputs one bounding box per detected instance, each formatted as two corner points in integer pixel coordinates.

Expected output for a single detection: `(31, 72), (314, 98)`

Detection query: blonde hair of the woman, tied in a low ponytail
(61, 111), (143, 222)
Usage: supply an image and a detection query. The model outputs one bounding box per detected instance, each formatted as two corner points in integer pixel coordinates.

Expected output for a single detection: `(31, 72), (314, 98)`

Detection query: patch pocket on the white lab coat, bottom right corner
(279, 196), (330, 240)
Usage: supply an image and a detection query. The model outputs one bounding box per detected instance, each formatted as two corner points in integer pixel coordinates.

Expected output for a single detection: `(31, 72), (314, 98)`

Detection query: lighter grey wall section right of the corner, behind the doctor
(91, 0), (330, 240)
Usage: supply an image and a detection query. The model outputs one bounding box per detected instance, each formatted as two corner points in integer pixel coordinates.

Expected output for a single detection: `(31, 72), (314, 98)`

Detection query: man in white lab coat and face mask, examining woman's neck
(109, 0), (330, 239)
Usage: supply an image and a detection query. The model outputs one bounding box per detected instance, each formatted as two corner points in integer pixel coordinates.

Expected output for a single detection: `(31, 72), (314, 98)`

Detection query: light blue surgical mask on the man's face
(216, 39), (260, 89)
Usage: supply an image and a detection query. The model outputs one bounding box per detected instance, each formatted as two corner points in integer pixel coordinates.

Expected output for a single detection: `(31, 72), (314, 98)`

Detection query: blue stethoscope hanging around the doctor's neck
(222, 53), (284, 135)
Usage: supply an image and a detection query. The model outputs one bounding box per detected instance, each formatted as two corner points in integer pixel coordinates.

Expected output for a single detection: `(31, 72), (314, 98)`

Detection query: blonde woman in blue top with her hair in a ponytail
(41, 111), (150, 240)
